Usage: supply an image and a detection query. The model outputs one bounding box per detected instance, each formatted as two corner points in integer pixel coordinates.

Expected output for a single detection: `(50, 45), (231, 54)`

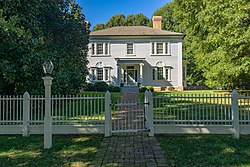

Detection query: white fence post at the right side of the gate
(147, 91), (154, 136)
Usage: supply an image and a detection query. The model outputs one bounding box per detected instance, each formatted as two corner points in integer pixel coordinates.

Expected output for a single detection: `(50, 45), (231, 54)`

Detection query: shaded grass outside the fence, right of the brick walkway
(157, 135), (250, 167)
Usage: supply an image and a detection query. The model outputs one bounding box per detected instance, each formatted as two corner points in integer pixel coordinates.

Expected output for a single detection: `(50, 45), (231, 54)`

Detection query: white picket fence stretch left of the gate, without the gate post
(0, 92), (105, 136)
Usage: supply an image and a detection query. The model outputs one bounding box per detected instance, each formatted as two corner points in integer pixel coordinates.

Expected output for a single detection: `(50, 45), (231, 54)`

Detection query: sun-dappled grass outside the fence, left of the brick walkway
(0, 135), (103, 167)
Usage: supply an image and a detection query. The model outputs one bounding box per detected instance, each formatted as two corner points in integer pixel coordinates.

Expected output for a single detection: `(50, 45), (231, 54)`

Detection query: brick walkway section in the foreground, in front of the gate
(95, 134), (167, 167)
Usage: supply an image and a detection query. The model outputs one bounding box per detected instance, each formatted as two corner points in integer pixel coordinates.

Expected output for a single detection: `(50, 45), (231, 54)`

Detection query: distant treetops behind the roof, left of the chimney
(93, 13), (149, 31)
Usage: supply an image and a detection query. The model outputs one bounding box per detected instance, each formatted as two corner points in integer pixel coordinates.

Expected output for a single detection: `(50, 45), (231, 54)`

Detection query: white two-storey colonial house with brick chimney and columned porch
(88, 16), (186, 90)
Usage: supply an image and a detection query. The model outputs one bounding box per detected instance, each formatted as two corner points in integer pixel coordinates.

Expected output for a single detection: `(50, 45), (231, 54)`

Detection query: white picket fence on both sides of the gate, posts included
(0, 91), (250, 137)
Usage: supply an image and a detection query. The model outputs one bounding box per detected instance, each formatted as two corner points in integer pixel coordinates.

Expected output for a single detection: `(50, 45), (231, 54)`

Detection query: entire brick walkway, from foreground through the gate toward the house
(95, 94), (167, 167)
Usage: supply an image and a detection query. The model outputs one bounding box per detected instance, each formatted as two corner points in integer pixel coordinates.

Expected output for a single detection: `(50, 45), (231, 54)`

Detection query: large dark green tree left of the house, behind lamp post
(0, 0), (89, 94)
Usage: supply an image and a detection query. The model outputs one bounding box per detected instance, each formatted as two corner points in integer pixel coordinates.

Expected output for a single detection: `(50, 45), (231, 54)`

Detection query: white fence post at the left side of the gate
(105, 91), (112, 137)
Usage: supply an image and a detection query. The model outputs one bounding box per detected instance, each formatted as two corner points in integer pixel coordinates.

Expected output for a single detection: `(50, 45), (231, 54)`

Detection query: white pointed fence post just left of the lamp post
(22, 91), (30, 136)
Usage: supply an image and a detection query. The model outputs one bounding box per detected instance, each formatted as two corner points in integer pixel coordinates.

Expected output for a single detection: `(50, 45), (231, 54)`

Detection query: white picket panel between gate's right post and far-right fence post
(153, 94), (232, 125)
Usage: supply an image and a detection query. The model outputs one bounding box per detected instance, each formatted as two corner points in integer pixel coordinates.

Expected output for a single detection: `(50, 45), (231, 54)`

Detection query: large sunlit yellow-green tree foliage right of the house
(154, 0), (250, 87)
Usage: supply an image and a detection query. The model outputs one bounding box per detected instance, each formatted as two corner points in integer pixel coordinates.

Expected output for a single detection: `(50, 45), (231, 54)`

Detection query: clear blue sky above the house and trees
(76, 0), (171, 29)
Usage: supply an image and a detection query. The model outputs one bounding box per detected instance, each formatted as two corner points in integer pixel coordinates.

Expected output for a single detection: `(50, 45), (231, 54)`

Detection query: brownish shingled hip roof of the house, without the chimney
(90, 26), (185, 37)
